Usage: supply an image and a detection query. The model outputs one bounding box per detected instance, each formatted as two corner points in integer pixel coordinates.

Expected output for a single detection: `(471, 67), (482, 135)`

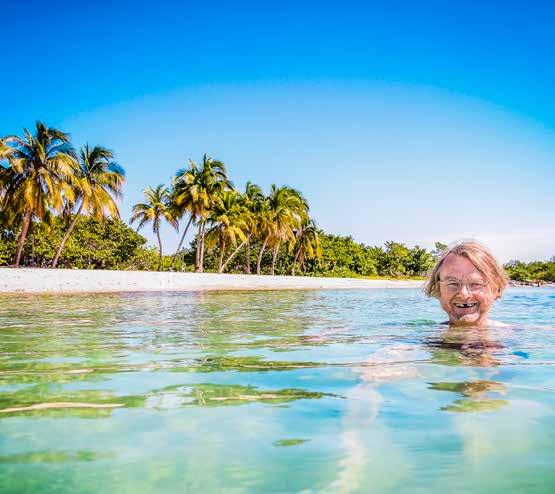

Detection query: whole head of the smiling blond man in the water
(424, 241), (507, 326)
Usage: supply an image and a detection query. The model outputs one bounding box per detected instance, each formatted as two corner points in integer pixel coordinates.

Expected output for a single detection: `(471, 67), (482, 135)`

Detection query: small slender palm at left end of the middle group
(129, 184), (178, 271)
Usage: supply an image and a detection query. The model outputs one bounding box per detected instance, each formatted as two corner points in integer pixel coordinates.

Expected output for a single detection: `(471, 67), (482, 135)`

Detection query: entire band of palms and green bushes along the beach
(0, 122), (551, 279)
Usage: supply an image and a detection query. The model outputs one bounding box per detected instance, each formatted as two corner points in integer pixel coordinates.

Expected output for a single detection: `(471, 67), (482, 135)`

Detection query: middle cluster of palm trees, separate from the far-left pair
(126, 155), (321, 274)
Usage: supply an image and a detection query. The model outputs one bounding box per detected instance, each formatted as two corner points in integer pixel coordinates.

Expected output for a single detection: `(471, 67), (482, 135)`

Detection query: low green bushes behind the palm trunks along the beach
(0, 216), (444, 278)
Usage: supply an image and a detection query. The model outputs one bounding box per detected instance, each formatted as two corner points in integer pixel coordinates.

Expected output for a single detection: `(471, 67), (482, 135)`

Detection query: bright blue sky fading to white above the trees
(0, 1), (555, 261)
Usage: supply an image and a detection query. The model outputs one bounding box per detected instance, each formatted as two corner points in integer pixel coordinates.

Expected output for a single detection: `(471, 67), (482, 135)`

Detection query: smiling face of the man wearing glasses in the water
(439, 254), (497, 326)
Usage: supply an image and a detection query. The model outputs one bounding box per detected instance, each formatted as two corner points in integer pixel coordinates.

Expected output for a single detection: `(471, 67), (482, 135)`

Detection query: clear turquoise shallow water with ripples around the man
(0, 288), (555, 493)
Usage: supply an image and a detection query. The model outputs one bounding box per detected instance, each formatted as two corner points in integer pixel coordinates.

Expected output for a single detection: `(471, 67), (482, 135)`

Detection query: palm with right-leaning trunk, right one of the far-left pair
(52, 144), (125, 268)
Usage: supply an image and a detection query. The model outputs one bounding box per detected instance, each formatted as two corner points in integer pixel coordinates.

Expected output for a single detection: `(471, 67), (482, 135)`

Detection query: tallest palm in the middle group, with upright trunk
(174, 154), (233, 273)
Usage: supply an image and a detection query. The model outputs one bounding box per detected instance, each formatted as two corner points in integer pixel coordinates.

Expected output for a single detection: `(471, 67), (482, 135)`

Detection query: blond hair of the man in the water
(424, 240), (507, 298)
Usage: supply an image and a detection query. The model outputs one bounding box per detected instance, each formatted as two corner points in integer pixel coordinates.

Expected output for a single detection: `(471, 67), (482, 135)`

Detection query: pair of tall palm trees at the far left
(0, 122), (125, 267)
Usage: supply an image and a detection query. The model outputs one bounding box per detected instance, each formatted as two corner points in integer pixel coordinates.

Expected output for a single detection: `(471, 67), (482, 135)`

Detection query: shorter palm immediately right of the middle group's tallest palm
(206, 190), (251, 273)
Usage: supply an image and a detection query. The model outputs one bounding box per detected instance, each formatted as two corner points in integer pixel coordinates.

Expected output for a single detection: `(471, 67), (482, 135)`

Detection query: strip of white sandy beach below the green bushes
(0, 268), (423, 293)
